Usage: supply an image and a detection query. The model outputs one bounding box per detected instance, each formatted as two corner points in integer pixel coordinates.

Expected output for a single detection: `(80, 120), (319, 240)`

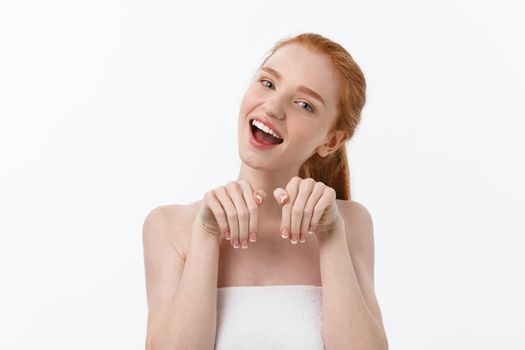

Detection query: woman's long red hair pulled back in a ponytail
(259, 33), (366, 200)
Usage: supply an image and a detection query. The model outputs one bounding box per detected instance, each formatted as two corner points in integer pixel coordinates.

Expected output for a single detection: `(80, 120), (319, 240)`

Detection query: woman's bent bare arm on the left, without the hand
(143, 206), (219, 350)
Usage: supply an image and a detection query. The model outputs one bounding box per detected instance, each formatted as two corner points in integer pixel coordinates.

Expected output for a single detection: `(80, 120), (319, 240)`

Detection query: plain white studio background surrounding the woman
(0, 0), (525, 350)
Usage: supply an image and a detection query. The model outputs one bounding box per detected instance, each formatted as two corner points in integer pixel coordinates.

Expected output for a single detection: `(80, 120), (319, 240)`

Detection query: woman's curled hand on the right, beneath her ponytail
(273, 176), (343, 244)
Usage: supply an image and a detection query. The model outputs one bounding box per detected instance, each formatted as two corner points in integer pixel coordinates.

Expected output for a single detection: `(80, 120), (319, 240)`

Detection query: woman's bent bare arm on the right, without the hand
(319, 202), (388, 350)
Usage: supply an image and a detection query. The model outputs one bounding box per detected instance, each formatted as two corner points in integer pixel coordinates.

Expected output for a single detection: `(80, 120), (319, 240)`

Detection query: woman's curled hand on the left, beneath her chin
(193, 180), (266, 248)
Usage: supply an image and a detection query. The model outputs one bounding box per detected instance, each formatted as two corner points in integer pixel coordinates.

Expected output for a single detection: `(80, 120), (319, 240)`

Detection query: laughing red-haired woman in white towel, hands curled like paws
(143, 33), (388, 350)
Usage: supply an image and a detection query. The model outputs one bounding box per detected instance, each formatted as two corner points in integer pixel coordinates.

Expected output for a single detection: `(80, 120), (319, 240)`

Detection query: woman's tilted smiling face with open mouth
(238, 44), (343, 170)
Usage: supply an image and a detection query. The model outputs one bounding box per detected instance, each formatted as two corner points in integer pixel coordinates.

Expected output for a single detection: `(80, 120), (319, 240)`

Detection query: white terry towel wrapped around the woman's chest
(215, 285), (324, 350)
